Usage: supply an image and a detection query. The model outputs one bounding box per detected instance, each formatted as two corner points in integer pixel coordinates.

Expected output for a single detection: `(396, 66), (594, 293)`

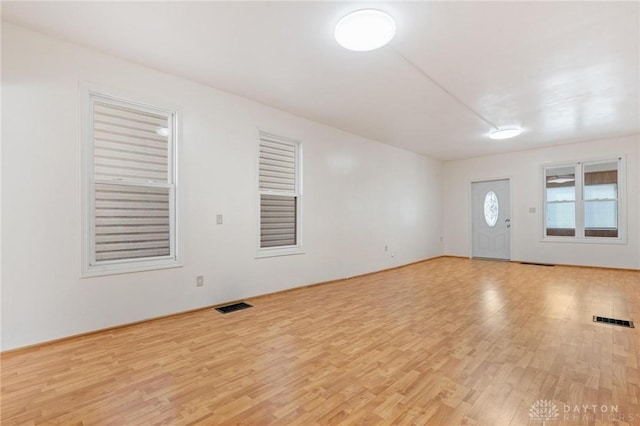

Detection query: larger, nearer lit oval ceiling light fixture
(334, 9), (396, 52)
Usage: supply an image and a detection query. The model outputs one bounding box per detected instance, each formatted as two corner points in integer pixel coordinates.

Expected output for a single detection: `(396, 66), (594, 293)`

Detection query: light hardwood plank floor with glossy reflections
(1, 258), (640, 426)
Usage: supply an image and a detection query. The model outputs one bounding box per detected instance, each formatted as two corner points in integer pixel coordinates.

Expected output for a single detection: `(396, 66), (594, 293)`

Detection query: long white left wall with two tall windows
(2, 23), (442, 350)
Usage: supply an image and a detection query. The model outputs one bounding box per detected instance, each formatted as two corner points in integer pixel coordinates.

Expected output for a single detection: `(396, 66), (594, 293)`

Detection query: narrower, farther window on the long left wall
(258, 133), (301, 250)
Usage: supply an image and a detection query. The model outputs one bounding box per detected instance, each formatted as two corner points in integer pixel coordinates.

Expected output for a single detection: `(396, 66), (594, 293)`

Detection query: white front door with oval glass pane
(471, 179), (511, 260)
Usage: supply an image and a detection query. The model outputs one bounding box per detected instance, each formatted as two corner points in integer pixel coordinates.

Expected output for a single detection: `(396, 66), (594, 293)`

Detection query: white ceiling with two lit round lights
(2, 1), (640, 159)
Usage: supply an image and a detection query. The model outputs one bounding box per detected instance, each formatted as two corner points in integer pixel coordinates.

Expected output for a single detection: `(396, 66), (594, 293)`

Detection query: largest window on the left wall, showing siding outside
(83, 91), (177, 275)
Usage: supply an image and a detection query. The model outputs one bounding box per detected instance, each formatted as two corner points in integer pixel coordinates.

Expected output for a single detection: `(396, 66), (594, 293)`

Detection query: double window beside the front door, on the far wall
(544, 159), (624, 240)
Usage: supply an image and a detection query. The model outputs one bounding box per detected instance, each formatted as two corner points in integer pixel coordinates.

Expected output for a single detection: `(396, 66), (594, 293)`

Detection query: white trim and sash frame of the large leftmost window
(79, 82), (182, 278)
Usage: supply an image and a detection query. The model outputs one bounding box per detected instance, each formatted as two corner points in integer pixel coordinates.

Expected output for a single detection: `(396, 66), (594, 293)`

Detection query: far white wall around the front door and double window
(443, 135), (640, 269)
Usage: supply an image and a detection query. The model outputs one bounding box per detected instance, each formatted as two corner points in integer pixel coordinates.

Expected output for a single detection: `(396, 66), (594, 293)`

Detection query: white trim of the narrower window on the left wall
(255, 129), (305, 259)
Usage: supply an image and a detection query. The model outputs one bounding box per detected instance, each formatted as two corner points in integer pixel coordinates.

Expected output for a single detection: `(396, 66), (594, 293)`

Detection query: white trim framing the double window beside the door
(540, 155), (628, 244)
